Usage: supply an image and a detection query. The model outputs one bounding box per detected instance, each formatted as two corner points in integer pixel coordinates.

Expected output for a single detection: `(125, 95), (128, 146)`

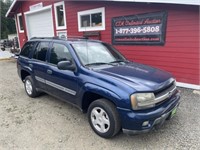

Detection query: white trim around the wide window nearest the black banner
(77, 7), (105, 32)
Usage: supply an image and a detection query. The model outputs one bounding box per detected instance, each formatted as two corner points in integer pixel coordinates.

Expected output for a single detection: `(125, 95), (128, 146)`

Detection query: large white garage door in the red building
(26, 9), (54, 39)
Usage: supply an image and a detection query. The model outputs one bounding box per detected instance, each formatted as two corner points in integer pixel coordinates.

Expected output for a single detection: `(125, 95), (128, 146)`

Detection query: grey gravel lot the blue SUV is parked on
(0, 60), (200, 150)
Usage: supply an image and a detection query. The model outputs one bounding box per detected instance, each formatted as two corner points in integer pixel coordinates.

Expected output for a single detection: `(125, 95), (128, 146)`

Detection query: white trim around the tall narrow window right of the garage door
(54, 1), (67, 30)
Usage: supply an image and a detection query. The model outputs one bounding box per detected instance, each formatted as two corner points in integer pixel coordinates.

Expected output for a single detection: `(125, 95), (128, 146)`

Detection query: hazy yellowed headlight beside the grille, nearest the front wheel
(131, 93), (155, 110)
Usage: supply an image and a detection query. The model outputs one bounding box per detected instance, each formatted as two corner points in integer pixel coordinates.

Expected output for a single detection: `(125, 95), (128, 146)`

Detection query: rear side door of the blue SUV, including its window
(29, 41), (49, 91)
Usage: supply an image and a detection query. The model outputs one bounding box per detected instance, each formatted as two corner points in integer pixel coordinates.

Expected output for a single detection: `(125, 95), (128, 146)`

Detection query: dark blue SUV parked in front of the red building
(17, 38), (180, 138)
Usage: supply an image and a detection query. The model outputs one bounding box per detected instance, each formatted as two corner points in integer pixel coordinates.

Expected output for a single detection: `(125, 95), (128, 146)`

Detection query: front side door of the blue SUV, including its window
(46, 43), (77, 103)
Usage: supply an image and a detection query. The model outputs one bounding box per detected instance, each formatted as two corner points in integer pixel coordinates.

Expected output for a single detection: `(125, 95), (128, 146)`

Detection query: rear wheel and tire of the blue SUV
(24, 76), (40, 98)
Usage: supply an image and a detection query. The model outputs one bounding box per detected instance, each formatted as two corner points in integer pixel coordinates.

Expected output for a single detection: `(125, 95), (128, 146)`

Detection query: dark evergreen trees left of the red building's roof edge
(0, 0), (16, 39)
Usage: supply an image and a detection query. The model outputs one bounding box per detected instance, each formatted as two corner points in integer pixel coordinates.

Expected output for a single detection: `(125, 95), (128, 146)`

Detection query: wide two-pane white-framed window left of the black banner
(78, 7), (105, 31)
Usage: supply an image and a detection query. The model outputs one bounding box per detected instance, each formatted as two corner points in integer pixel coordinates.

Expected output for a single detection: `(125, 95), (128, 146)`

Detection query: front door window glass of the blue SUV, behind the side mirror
(50, 43), (72, 65)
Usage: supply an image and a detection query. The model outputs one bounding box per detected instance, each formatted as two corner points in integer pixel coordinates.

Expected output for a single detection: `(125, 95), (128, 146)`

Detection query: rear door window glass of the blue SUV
(33, 42), (49, 61)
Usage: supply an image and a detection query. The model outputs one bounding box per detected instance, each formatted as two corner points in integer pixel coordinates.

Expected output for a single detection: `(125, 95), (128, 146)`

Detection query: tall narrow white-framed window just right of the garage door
(54, 1), (66, 30)
